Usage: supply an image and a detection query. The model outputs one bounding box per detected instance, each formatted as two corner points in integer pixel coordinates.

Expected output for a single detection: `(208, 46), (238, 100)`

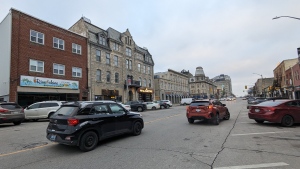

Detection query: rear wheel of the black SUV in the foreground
(79, 131), (99, 151)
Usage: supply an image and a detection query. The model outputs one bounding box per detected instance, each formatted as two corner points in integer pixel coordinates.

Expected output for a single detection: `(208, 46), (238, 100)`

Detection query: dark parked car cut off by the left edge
(0, 102), (25, 125)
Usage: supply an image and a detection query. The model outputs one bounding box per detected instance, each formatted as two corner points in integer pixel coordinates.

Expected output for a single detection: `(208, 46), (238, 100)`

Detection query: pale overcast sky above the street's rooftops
(0, 0), (300, 96)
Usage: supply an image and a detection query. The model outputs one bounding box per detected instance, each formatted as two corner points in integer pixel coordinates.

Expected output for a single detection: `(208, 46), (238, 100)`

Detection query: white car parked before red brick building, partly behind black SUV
(24, 101), (66, 121)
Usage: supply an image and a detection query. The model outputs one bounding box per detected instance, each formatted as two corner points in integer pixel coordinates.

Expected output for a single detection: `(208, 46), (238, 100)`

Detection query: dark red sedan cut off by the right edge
(248, 100), (300, 127)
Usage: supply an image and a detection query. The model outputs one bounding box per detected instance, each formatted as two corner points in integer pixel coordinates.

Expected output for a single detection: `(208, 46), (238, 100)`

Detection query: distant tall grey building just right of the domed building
(212, 74), (233, 98)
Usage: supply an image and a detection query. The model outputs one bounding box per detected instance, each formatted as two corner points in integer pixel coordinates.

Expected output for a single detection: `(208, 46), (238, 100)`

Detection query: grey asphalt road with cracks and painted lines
(0, 99), (300, 169)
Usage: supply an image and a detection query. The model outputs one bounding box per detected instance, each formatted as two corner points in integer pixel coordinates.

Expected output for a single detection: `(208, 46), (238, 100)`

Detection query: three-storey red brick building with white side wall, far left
(0, 9), (88, 106)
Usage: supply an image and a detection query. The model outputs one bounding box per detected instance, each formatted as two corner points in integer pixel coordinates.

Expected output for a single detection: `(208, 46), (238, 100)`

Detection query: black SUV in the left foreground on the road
(47, 101), (144, 151)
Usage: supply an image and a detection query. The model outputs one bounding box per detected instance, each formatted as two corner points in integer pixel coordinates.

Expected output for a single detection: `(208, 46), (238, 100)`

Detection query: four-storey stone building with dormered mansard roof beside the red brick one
(69, 17), (154, 102)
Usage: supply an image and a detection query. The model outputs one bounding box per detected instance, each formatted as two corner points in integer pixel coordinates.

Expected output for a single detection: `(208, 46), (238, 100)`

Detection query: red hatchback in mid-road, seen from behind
(186, 100), (230, 125)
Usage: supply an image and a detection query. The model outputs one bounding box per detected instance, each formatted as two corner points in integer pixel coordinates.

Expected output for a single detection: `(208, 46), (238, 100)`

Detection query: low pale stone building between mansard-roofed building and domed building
(154, 69), (189, 103)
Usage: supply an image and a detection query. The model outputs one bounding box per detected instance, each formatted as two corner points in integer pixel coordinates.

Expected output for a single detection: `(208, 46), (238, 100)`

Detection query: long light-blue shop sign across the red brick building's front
(20, 76), (79, 90)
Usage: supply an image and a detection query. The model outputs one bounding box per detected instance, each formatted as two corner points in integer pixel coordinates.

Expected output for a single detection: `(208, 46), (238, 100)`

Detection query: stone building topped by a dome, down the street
(189, 66), (217, 99)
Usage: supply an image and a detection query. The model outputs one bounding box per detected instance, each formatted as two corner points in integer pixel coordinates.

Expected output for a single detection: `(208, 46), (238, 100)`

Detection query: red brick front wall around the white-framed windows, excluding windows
(10, 10), (87, 101)
